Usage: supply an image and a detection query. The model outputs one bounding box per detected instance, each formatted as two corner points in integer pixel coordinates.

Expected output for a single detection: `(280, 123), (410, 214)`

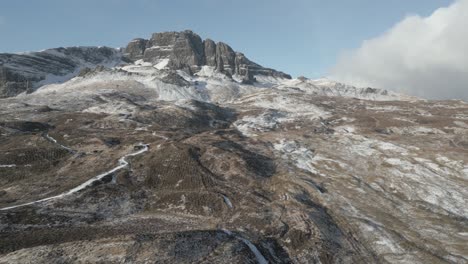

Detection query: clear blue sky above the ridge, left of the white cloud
(0, 0), (453, 77)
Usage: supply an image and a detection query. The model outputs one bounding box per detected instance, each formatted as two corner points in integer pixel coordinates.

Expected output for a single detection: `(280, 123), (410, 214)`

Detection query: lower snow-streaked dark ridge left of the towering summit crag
(0, 47), (121, 98)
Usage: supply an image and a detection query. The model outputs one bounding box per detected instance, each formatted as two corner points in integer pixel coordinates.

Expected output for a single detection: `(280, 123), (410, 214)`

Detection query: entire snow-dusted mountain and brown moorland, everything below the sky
(0, 31), (468, 263)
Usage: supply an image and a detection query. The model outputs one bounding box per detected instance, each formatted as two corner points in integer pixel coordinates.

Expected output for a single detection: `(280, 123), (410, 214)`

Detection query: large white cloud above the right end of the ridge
(330, 0), (468, 100)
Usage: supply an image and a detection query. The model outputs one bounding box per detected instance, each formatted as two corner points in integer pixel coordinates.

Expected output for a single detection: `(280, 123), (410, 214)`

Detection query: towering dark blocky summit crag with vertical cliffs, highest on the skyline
(124, 30), (291, 83)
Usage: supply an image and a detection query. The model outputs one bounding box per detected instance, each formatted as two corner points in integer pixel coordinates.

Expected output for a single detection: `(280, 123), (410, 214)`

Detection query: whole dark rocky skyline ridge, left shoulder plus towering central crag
(0, 31), (291, 97)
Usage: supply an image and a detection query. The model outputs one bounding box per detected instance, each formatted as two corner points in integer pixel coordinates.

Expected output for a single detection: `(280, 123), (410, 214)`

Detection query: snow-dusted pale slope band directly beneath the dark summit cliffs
(23, 58), (415, 113)
